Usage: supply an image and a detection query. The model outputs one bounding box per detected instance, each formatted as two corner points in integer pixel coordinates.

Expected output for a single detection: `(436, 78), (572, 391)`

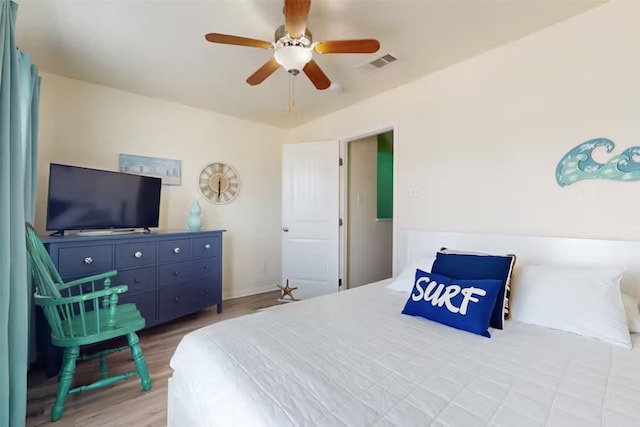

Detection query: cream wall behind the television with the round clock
(36, 74), (285, 297)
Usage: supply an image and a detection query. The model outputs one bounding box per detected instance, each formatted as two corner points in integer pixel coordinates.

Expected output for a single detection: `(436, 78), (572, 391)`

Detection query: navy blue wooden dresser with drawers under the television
(36, 230), (224, 376)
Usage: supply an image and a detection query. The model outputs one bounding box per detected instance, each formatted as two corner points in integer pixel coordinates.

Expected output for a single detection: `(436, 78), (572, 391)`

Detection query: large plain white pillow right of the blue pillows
(511, 265), (631, 348)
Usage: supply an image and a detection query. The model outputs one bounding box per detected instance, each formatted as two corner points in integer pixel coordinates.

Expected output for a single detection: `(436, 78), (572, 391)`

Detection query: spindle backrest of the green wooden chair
(25, 222), (64, 298)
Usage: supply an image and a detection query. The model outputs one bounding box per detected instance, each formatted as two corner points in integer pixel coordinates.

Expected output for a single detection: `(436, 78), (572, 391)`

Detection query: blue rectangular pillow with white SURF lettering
(402, 269), (502, 338)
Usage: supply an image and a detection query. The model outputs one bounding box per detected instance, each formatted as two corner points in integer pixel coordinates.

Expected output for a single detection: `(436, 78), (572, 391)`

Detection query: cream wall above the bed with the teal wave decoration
(289, 2), (640, 239)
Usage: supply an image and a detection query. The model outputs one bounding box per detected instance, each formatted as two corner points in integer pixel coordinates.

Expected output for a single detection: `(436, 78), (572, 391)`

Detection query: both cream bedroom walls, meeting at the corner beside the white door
(36, 1), (640, 297)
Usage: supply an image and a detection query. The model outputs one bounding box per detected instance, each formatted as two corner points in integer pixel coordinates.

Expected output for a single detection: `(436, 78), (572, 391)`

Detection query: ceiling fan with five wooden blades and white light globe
(205, 0), (380, 90)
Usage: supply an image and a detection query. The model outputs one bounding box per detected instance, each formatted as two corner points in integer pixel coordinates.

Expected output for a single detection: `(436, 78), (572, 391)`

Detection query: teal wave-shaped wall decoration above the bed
(556, 138), (640, 187)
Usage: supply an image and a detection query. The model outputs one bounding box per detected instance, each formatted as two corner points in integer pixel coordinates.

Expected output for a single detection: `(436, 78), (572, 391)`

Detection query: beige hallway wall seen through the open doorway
(347, 136), (393, 288)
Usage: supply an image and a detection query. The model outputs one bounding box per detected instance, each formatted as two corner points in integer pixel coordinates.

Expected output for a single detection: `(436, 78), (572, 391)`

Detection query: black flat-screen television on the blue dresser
(47, 163), (162, 230)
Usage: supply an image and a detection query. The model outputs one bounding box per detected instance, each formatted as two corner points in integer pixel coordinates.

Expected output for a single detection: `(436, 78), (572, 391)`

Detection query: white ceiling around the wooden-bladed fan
(17, 0), (602, 128)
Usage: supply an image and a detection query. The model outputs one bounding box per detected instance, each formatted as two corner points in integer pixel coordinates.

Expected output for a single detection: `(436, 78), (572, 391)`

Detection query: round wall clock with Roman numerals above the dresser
(198, 162), (240, 204)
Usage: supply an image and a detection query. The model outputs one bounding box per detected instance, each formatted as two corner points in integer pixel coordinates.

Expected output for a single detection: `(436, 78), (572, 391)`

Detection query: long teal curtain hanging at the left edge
(0, 0), (40, 427)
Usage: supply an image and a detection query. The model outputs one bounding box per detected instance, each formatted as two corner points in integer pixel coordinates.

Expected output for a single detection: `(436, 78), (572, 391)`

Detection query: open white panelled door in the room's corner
(282, 141), (340, 299)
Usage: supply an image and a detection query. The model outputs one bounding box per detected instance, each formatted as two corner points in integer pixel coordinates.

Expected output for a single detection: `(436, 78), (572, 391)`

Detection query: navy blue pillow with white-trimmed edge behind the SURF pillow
(431, 249), (516, 329)
